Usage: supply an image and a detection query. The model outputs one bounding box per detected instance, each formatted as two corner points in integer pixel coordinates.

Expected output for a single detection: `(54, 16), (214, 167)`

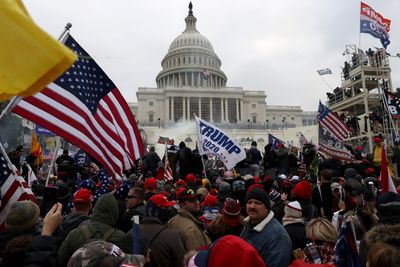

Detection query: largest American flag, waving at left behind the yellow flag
(13, 34), (144, 178)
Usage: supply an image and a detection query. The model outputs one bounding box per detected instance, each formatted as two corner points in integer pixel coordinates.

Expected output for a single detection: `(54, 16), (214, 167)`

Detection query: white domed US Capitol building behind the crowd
(129, 3), (317, 148)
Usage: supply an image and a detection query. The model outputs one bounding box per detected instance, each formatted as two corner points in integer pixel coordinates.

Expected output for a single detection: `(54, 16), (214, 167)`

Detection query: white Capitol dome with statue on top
(156, 3), (227, 88)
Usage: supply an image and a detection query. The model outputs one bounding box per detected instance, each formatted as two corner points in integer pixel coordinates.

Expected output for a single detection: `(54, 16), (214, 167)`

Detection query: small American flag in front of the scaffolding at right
(318, 101), (350, 141)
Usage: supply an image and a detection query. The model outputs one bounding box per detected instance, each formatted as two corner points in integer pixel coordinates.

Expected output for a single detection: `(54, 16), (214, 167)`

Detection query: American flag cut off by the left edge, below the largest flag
(0, 153), (36, 230)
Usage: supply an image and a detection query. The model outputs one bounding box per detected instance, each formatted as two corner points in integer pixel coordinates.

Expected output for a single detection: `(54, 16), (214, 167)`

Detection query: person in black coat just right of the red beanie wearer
(311, 169), (333, 220)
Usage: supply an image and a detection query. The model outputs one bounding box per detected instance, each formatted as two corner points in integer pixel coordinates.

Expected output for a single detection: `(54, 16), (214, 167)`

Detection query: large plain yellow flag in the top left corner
(0, 0), (77, 100)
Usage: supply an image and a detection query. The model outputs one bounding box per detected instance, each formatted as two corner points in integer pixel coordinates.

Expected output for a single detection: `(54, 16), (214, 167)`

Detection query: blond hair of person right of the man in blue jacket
(306, 218), (338, 243)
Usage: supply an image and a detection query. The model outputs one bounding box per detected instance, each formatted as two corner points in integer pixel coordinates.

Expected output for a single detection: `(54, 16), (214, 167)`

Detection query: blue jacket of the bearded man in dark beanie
(240, 211), (292, 267)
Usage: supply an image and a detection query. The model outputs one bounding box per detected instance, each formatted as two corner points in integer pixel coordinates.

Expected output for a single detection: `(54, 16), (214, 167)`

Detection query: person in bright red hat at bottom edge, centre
(188, 235), (265, 267)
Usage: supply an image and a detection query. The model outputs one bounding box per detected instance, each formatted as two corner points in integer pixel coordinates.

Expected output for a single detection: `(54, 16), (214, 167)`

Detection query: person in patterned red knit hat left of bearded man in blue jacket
(207, 197), (244, 242)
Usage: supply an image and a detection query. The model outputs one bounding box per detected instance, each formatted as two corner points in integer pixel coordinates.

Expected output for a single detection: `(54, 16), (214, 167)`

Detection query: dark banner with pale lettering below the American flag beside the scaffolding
(318, 125), (354, 161)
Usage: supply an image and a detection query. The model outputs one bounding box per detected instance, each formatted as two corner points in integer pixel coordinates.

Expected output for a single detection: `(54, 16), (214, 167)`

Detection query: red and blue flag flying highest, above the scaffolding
(360, 2), (391, 49)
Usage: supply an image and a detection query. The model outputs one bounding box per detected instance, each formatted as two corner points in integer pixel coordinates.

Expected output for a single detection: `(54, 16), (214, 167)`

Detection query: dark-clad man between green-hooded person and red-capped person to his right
(118, 187), (145, 232)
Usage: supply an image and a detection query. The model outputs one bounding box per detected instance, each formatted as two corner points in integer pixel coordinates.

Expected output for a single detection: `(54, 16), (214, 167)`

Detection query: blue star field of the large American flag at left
(54, 42), (115, 114)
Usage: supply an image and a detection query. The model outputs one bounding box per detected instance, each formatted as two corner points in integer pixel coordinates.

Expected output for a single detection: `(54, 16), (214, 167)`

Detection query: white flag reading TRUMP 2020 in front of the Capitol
(195, 116), (246, 170)
